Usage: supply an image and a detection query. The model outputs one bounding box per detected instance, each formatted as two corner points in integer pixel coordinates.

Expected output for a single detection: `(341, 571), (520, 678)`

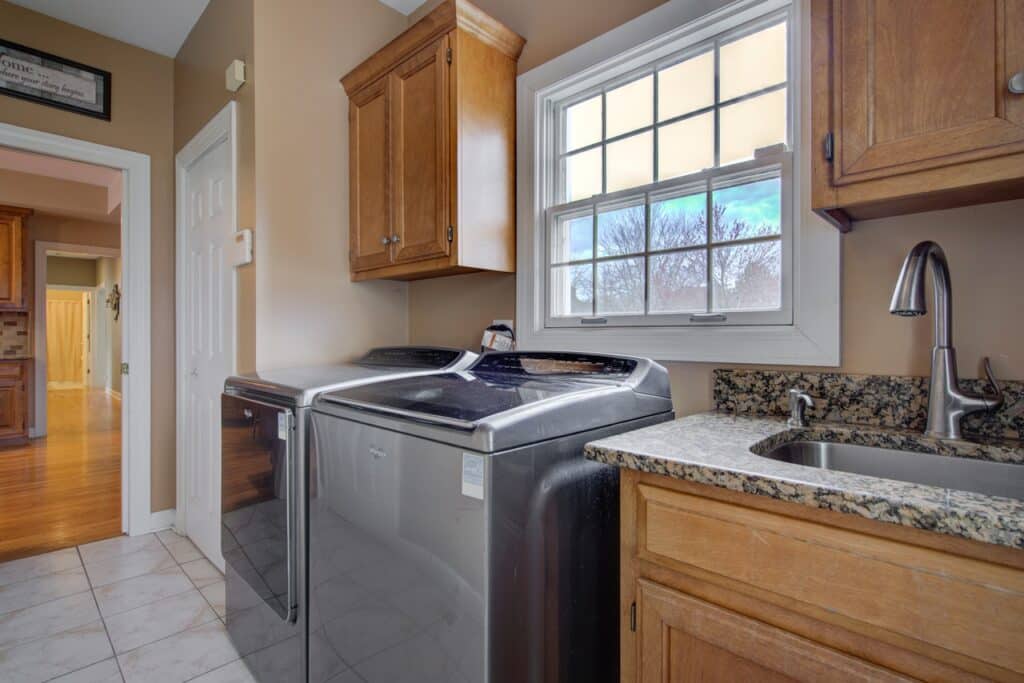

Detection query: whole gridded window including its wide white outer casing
(517, 0), (840, 365)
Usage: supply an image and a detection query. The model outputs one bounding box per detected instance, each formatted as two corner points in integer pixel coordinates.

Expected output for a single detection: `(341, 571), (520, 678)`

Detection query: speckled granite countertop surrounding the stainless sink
(586, 412), (1024, 548)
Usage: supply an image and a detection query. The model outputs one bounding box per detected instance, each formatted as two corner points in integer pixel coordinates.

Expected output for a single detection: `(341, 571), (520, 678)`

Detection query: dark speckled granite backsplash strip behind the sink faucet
(714, 369), (1024, 439)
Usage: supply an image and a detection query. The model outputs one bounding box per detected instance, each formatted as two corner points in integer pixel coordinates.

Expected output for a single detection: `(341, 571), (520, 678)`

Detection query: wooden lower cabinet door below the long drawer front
(635, 579), (909, 683)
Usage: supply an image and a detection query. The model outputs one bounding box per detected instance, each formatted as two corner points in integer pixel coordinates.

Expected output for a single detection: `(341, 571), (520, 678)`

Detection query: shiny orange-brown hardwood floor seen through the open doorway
(0, 388), (121, 562)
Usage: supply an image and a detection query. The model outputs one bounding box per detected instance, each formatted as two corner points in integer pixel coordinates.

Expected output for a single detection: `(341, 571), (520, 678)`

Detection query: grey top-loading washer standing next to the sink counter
(309, 352), (673, 683)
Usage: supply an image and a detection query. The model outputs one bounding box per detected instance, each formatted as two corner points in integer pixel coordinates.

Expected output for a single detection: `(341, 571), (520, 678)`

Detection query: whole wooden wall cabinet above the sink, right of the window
(811, 0), (1024, 229)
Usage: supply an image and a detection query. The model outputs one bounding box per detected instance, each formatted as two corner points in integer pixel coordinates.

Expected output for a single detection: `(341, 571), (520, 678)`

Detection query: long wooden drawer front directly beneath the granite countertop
(636, 484), (1024, 674)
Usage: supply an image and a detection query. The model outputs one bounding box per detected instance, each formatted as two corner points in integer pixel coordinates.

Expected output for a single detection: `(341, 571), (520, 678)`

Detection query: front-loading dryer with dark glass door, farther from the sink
(221, 347), (477, 683)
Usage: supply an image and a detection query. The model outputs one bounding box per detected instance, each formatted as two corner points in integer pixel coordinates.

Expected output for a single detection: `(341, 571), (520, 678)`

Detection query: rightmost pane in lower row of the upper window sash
(720, 88), (786, 166)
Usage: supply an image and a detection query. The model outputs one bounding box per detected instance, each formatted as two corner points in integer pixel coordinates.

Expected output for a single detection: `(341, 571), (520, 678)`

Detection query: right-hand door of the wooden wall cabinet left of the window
(391, 36), (450, 263)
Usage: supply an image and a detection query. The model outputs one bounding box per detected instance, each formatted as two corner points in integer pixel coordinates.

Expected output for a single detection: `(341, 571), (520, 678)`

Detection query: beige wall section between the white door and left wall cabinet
(255, 0), (408, 369)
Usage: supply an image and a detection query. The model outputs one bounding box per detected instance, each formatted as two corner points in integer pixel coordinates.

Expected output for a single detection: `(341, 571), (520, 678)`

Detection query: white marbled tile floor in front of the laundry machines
(0, 530), (254, 683)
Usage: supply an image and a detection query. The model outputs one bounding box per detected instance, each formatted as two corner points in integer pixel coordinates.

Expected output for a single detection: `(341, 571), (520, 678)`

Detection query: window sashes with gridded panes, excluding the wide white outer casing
(547, 12), (792, 326)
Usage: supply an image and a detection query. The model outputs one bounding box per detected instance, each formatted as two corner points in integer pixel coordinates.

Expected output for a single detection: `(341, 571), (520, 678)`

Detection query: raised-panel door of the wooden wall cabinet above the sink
(833, 0), (1024, 187)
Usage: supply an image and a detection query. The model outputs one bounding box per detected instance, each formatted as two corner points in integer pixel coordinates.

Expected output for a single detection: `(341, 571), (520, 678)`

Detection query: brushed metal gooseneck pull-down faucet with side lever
(889, 241), (1002, 438)
